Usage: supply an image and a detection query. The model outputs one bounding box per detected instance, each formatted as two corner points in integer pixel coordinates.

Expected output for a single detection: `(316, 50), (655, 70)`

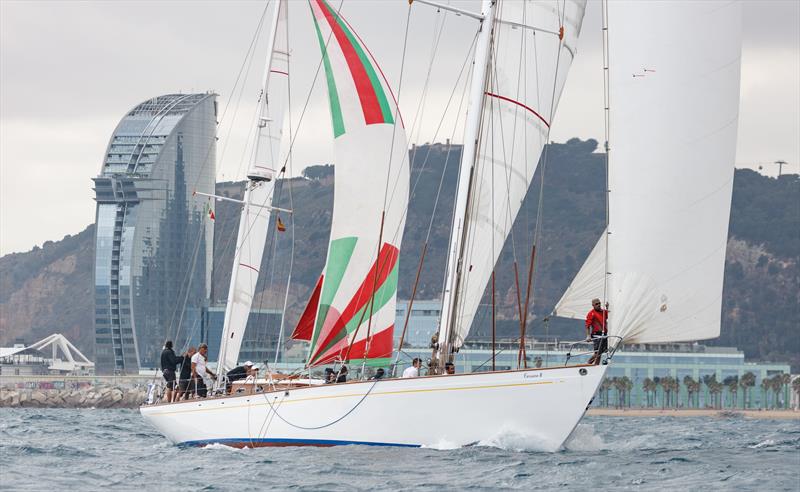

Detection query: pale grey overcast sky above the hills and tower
(0, 0), (800, 254)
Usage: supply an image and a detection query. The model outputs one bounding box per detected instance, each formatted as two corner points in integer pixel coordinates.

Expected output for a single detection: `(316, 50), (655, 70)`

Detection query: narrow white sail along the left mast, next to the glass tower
(218, 1), (289, 373)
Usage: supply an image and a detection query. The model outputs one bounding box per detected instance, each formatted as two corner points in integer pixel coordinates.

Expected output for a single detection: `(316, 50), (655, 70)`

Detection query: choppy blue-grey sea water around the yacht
(0, 409), (800, 492)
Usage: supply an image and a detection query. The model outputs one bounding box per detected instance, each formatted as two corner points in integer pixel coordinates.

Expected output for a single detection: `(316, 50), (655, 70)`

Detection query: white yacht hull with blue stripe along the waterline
(141, 366), (607, 451)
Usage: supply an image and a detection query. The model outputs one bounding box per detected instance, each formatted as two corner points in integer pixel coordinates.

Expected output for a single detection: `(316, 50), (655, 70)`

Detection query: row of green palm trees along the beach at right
(599, 371), (800, 409)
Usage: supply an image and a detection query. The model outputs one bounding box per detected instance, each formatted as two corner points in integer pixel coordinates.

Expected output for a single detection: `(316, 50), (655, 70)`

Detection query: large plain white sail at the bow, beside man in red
(556, 1), (741, 343)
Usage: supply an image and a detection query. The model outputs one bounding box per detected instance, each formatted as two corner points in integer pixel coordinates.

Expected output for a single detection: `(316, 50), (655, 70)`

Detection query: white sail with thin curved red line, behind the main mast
(439, 0), (586, 348)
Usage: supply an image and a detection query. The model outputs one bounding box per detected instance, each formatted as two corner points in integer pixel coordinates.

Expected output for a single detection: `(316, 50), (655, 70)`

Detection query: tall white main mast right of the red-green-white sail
(438, 0), (497, 370)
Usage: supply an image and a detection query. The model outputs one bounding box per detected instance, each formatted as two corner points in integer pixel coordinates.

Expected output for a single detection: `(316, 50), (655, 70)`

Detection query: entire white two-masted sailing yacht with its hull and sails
(141, 0), (741, 450)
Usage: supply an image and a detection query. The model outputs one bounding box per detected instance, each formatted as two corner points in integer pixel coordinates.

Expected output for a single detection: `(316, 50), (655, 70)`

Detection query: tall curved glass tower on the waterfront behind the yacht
(94, 93), (217, 374)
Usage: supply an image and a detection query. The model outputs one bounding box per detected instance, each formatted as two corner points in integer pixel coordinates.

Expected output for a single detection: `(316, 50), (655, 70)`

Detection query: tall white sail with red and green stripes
(308, 0), (409, 366)
